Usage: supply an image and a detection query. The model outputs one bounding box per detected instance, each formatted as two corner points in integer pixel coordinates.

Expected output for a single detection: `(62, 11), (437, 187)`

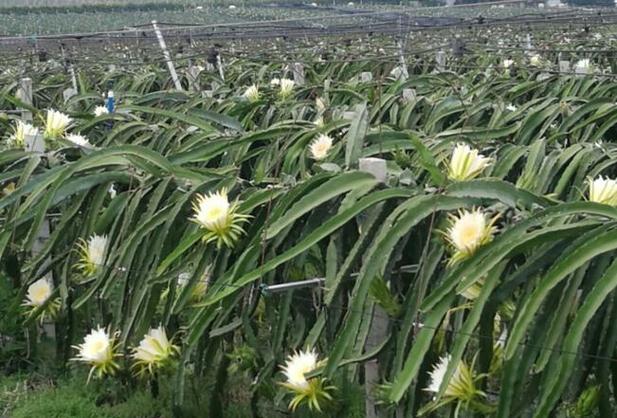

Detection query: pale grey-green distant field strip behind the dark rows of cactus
(0, 0), (541, 36)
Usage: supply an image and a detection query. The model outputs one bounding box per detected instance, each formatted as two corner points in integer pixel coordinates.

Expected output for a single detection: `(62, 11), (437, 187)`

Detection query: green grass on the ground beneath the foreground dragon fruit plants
(0, 373), (364, 418)
